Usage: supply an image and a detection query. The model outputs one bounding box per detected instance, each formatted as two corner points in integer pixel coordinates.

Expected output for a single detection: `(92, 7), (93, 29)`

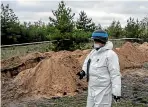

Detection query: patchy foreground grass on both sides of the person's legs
(36, 92), (146, 107)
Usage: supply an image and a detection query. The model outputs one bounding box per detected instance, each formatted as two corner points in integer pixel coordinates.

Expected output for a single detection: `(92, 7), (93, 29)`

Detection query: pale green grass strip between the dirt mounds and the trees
(1, 41), (123, 60)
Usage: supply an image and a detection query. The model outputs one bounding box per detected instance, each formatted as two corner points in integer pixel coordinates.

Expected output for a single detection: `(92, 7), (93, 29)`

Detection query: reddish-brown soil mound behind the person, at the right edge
(114, 42), (148, 70)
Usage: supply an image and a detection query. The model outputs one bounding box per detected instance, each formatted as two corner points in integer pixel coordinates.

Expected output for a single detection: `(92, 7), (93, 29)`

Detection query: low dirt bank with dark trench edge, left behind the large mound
(1, 52), (53, 77)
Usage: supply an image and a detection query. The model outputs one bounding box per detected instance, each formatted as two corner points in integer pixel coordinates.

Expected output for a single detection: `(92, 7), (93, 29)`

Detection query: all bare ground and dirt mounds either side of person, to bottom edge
(1, 42), (148, 107)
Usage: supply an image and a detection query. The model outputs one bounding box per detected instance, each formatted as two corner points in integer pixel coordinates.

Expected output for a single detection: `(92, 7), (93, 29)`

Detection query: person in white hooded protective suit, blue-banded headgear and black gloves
(77, 30), (121, 107)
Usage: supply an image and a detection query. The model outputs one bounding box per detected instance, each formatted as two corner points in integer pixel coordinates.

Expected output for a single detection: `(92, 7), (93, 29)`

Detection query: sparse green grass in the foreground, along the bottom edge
(14, 92), (146, 107)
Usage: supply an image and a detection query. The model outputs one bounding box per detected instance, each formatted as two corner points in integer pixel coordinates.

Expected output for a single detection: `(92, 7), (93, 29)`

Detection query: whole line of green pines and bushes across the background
(1, 1), (148, 50)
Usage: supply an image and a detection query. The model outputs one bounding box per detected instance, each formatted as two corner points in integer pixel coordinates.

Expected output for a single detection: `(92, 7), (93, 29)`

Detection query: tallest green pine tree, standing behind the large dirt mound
(49, 1), (75, 51)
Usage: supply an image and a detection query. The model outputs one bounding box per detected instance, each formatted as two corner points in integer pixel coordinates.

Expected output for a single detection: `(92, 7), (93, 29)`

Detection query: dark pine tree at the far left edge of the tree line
(1, 4), (20, 44)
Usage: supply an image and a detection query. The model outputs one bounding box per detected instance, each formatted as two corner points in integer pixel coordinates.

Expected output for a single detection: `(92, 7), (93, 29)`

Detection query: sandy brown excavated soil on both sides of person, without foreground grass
(1, 42), (148, 104)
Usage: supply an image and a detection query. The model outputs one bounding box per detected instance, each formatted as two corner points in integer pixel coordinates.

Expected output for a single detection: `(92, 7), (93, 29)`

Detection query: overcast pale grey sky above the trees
(1, 0), (148, 27)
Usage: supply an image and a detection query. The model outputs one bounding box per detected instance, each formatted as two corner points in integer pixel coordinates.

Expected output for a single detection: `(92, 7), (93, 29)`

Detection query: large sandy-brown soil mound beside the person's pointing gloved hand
(14, 51), (87, 97)
